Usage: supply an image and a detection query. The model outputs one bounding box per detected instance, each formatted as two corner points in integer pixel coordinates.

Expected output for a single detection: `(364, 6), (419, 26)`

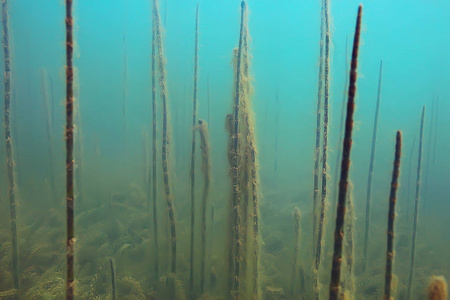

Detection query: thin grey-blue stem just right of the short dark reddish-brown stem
(406, 106), (425, 299)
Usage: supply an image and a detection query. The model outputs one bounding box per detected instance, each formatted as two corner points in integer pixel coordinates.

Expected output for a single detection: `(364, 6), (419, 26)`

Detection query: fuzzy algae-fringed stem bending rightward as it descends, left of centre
(153, 0), (177, 274)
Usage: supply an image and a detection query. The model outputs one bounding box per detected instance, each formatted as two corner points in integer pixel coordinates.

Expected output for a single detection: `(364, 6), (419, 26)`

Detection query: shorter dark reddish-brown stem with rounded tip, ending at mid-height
(384, 131), (402, 300)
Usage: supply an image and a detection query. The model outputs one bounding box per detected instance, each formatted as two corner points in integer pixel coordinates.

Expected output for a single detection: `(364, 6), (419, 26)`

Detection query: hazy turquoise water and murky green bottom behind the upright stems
(0, 0), (450, 299)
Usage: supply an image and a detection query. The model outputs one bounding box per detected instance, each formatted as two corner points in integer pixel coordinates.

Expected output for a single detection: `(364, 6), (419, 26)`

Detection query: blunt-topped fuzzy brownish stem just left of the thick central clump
(196, 120), (211, 294)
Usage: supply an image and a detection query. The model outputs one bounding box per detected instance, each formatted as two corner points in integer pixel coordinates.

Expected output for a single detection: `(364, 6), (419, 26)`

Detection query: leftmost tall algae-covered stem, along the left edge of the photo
(2, 0), (19, 299)
